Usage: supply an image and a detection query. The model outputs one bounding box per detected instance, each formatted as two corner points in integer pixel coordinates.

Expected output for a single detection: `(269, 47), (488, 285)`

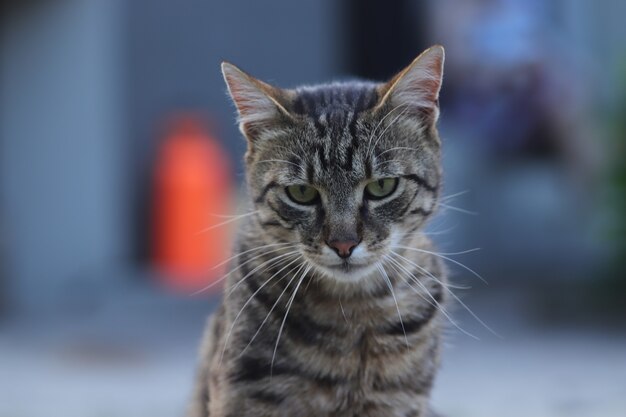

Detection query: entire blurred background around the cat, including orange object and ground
(0, 0), (626, 417)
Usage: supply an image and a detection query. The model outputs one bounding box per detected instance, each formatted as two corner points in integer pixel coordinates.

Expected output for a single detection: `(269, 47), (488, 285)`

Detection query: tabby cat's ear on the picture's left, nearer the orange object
(222, 62), (291, 143)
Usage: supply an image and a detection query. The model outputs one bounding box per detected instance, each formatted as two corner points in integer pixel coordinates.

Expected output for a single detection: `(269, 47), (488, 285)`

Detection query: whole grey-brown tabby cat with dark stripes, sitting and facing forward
(189, 46), (446, 417)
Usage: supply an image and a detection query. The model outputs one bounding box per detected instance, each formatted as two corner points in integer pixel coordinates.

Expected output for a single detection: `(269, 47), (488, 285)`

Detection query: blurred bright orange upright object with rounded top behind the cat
(153, 116), (233, 291)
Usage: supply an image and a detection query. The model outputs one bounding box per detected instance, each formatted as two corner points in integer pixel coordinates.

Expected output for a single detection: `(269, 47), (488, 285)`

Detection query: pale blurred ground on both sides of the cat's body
(0, 286), (626, 417)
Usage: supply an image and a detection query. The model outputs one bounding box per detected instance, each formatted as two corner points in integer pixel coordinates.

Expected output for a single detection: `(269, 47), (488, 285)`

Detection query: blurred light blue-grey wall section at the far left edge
(0, 0), (128, 309)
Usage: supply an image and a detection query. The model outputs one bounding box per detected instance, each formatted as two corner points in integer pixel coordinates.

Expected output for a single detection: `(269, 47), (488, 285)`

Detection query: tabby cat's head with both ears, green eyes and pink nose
(222, 46), (444, 282)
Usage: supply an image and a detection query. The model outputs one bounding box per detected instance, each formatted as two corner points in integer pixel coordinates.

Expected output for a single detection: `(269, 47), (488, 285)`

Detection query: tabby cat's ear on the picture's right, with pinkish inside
(377, 45), (445, 122)
